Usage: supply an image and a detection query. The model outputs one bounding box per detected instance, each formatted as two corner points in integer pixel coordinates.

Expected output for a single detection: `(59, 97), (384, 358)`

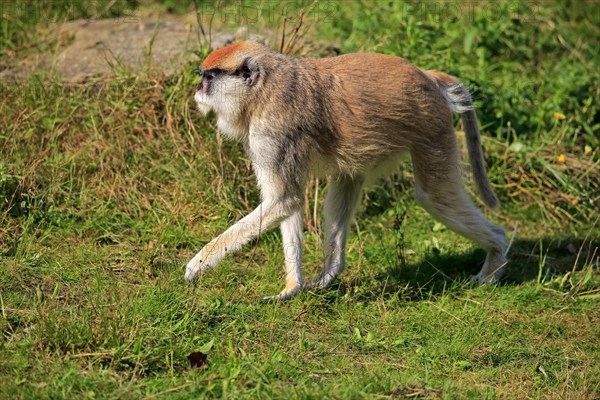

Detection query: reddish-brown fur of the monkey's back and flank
(306, 53), (454, 170)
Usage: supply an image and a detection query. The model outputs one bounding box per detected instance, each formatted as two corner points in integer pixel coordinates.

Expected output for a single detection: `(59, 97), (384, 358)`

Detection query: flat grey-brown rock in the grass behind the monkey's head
(0, 16), (265, 83)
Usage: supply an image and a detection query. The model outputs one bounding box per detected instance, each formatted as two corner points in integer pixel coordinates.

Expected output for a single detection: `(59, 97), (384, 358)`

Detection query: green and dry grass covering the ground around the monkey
(0, 1), (600, 399)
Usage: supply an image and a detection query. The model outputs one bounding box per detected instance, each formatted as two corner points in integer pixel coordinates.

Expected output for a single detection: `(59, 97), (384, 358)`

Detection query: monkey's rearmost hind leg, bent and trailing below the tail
(412, 142), (506, 284)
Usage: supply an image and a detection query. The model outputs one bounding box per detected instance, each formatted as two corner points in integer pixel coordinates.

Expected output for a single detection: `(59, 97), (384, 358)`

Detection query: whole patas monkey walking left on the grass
(185, 42), (505, 299)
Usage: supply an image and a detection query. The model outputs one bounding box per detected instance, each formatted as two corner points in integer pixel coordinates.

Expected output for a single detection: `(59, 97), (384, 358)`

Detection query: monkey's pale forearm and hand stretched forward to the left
(185, 200), (300, 281)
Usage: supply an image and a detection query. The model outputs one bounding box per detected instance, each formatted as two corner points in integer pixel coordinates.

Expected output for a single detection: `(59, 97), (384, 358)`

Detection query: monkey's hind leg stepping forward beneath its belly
(304, 176), (364, 289)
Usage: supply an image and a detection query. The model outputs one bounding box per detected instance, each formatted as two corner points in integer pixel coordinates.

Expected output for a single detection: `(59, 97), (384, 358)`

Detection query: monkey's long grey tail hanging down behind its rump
(425, 71), (500, 209)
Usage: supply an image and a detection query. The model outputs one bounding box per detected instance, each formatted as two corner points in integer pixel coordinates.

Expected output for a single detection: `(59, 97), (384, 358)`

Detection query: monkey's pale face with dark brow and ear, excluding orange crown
(194, 59), (258, 119)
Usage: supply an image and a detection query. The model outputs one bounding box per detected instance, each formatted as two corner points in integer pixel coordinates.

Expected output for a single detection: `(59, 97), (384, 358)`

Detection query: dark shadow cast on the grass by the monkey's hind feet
(318, 237), (600, 301)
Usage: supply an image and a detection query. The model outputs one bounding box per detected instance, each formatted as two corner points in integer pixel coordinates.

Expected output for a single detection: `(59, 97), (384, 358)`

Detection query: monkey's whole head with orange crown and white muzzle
(194, 42), (269, 121)
